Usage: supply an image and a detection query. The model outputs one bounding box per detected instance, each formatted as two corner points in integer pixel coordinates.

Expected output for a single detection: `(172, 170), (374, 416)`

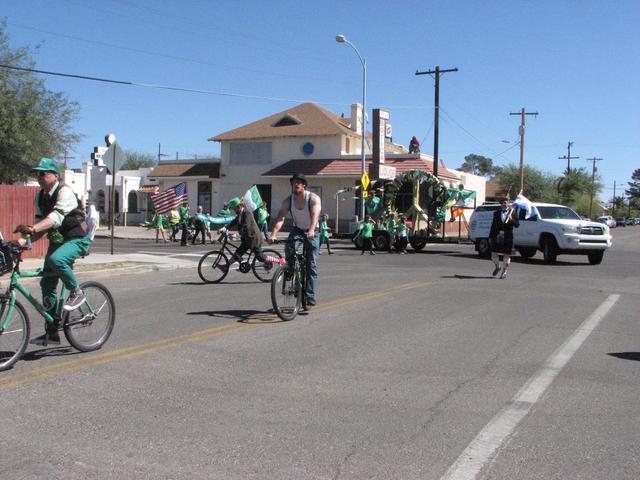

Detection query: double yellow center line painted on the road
(0, 282), (428, 391)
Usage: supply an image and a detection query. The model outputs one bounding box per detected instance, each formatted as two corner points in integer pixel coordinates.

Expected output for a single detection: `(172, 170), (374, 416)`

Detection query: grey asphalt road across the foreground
(0, 227), (640, 480)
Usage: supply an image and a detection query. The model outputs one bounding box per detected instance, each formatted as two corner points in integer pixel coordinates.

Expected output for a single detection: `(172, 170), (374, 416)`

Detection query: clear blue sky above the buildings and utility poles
(0, 0), (640, 199)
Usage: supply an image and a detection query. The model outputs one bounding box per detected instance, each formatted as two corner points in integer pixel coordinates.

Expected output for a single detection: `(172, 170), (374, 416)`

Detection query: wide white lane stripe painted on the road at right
(442, 294), (620, 480)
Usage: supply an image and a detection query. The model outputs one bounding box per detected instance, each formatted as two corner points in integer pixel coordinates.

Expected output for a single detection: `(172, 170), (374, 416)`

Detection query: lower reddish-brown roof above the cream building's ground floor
(262, 156), (460, 180)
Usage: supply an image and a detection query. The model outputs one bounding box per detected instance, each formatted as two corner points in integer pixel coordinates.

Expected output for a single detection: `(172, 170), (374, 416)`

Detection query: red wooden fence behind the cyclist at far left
(0, 184), (49, 258)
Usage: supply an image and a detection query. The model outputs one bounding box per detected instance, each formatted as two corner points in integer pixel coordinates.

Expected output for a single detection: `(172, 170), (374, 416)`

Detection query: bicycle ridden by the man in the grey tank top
(271, 240), (311, 322)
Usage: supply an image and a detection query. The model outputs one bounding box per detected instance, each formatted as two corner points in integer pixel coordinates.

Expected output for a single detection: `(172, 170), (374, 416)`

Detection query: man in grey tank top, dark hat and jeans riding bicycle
(269, 173), (322, 306)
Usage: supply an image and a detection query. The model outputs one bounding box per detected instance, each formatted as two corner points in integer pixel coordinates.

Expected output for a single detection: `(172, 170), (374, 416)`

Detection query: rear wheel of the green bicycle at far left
(62, 282), (116, 352)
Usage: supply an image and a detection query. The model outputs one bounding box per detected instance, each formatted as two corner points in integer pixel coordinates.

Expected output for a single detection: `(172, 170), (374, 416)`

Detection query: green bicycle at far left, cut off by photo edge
(0, 240), (116, 371)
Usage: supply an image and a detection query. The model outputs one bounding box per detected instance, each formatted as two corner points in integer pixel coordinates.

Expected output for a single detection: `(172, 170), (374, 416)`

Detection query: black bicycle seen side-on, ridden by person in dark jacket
(198, 232), (282, 283)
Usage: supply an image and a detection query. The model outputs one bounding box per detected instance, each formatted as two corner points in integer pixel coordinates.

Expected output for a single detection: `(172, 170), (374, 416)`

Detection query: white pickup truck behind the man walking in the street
(469, 203), (611, 265)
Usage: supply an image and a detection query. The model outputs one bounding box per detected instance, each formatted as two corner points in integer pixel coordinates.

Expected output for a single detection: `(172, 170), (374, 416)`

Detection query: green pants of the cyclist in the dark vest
(40, 237), (91, 316)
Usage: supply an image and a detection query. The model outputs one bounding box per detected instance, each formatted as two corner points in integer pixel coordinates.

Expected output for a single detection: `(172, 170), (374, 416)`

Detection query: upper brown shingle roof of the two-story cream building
(208, 103), (359, 142)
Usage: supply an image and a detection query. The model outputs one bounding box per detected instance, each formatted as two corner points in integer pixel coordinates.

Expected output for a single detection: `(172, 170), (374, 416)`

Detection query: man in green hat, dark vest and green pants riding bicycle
(15, 158), (91, 345)
